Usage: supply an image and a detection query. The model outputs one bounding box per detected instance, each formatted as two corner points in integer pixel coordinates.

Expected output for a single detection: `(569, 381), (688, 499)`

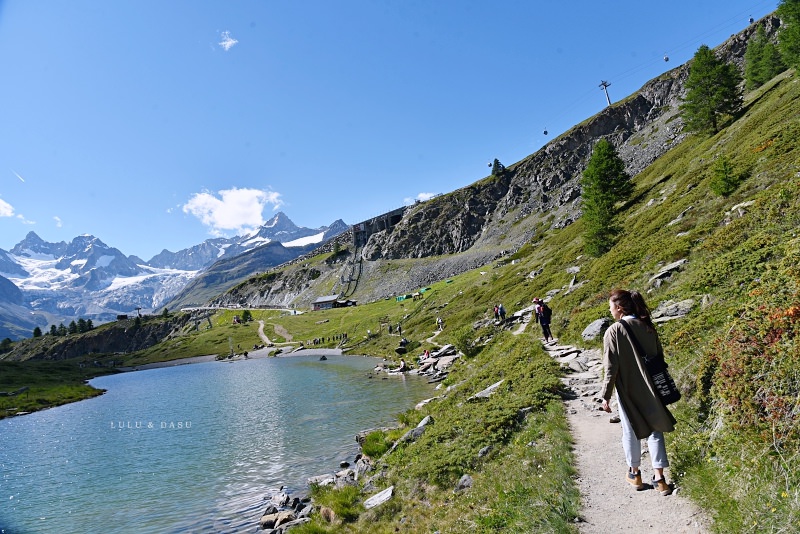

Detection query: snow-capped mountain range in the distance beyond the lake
(0, 213), (348, 339)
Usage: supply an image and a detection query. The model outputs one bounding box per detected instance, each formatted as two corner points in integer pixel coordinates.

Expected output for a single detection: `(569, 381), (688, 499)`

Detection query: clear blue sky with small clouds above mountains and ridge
(0, 0), (778, 260)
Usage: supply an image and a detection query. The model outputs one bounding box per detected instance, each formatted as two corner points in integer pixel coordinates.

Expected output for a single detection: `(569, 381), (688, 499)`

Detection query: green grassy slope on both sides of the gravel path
(300, 72), (800, 532)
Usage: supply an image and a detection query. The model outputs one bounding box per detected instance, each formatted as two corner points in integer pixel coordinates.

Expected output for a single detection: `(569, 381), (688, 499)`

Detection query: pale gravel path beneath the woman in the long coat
(545, 345), (711, 534)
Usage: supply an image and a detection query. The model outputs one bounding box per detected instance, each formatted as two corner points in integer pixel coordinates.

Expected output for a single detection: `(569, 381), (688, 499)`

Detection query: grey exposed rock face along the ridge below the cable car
(354, 17), (780, 285)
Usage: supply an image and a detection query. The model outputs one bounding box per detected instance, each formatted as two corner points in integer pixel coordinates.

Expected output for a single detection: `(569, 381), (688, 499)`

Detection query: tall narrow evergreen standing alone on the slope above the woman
(581, 139), (633, 256)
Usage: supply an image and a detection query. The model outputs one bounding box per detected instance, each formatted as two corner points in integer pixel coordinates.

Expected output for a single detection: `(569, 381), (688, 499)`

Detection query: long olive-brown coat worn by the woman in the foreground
(601, 318), (676, 439)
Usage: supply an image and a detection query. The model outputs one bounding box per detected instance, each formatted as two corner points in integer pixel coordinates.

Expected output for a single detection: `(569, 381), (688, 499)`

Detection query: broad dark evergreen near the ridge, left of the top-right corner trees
(680, 45), (742, 133)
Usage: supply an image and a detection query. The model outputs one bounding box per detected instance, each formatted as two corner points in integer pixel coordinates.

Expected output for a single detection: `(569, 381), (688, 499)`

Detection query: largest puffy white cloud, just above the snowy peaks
(182, 187), (283, 235)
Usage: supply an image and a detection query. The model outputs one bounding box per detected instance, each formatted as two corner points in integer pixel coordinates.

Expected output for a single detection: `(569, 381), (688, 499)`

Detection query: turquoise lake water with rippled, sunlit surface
(0, 356), (433, 534)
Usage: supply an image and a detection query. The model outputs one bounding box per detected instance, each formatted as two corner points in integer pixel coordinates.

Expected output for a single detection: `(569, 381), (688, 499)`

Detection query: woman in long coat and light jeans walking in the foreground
(601, 289), (676, 495)
